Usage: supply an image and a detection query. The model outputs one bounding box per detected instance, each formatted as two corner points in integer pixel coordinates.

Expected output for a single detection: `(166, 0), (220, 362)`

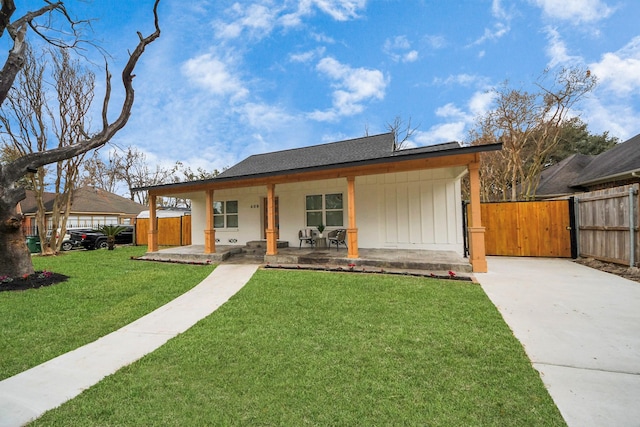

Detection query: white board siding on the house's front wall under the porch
(190, 167), (466, 254)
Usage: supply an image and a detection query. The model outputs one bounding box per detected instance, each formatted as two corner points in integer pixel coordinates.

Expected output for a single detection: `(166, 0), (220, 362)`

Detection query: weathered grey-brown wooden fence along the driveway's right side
(575, 184), (640, 267)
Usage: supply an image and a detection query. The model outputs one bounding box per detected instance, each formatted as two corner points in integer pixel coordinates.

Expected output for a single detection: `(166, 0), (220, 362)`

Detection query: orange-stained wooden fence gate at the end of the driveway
(480, 200), (571, 258)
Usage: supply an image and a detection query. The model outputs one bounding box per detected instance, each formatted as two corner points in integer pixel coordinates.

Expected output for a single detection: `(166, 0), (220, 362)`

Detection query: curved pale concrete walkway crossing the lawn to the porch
(0, 265), (258, 427)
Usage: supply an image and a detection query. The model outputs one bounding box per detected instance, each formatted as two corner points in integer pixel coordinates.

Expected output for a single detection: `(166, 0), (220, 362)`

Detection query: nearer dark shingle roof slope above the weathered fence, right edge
(572, 134), (640, 186)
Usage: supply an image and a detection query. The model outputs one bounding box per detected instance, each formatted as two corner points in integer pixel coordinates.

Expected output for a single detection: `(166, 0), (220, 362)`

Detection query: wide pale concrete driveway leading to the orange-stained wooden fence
(475, 257), (640, 426)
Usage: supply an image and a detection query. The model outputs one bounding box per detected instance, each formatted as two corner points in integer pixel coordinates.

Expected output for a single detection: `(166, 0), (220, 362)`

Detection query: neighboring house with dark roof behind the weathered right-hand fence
(536, 135), (640, 199)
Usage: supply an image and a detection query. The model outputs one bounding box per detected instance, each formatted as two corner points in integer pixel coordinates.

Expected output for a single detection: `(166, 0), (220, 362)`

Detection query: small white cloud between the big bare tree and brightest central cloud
(182, 53), (249, 99)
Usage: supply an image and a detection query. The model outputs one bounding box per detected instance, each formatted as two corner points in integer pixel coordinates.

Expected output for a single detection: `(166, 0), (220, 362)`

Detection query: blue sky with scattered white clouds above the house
(22, 0), (640, 174)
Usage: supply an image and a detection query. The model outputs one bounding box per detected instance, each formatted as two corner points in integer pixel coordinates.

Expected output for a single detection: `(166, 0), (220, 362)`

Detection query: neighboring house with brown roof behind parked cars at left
(20, 186), (147, 234)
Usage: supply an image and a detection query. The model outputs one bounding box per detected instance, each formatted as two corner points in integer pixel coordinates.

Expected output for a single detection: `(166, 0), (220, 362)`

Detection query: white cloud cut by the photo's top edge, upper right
(532, 0), (614, 24)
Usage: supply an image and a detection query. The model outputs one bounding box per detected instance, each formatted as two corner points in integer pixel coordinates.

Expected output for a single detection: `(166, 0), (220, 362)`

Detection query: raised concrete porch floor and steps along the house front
(141, 244), (472, 276)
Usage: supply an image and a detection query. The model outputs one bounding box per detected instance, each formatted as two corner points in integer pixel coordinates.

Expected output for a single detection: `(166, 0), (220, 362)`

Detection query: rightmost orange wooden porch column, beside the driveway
(468, 158), (487, 273)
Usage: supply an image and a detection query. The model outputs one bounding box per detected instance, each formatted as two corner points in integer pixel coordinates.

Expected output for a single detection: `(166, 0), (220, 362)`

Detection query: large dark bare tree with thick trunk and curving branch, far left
(0, 0), (160, 277)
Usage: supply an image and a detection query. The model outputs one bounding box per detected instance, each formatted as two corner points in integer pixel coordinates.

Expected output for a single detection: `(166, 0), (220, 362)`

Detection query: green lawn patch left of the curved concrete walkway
(0, 246), (213, 379)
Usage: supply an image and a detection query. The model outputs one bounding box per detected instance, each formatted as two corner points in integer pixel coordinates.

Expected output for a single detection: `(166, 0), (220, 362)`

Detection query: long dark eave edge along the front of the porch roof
(138, 142), (502, 191)
